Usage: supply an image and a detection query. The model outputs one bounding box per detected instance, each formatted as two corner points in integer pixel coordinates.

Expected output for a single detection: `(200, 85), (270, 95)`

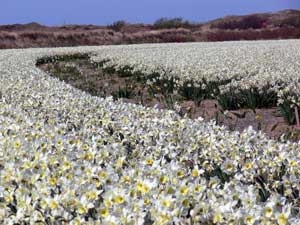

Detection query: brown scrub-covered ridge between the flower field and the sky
(0, 10), (300, 49)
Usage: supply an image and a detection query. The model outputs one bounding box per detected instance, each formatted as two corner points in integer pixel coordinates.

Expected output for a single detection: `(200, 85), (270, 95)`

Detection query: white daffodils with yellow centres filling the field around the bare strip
(0, 40), (300, 225)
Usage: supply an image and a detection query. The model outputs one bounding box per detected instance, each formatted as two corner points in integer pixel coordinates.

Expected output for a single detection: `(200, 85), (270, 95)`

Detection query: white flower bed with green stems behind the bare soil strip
(92, 40), (300, 124)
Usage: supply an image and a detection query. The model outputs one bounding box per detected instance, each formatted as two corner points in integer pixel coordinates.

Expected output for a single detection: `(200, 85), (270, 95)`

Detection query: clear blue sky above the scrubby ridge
(0, 0), (300, 25)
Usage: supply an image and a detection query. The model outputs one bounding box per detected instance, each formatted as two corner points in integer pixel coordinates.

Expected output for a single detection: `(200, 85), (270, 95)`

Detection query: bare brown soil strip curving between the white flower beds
(39, 59), (300, 141)
